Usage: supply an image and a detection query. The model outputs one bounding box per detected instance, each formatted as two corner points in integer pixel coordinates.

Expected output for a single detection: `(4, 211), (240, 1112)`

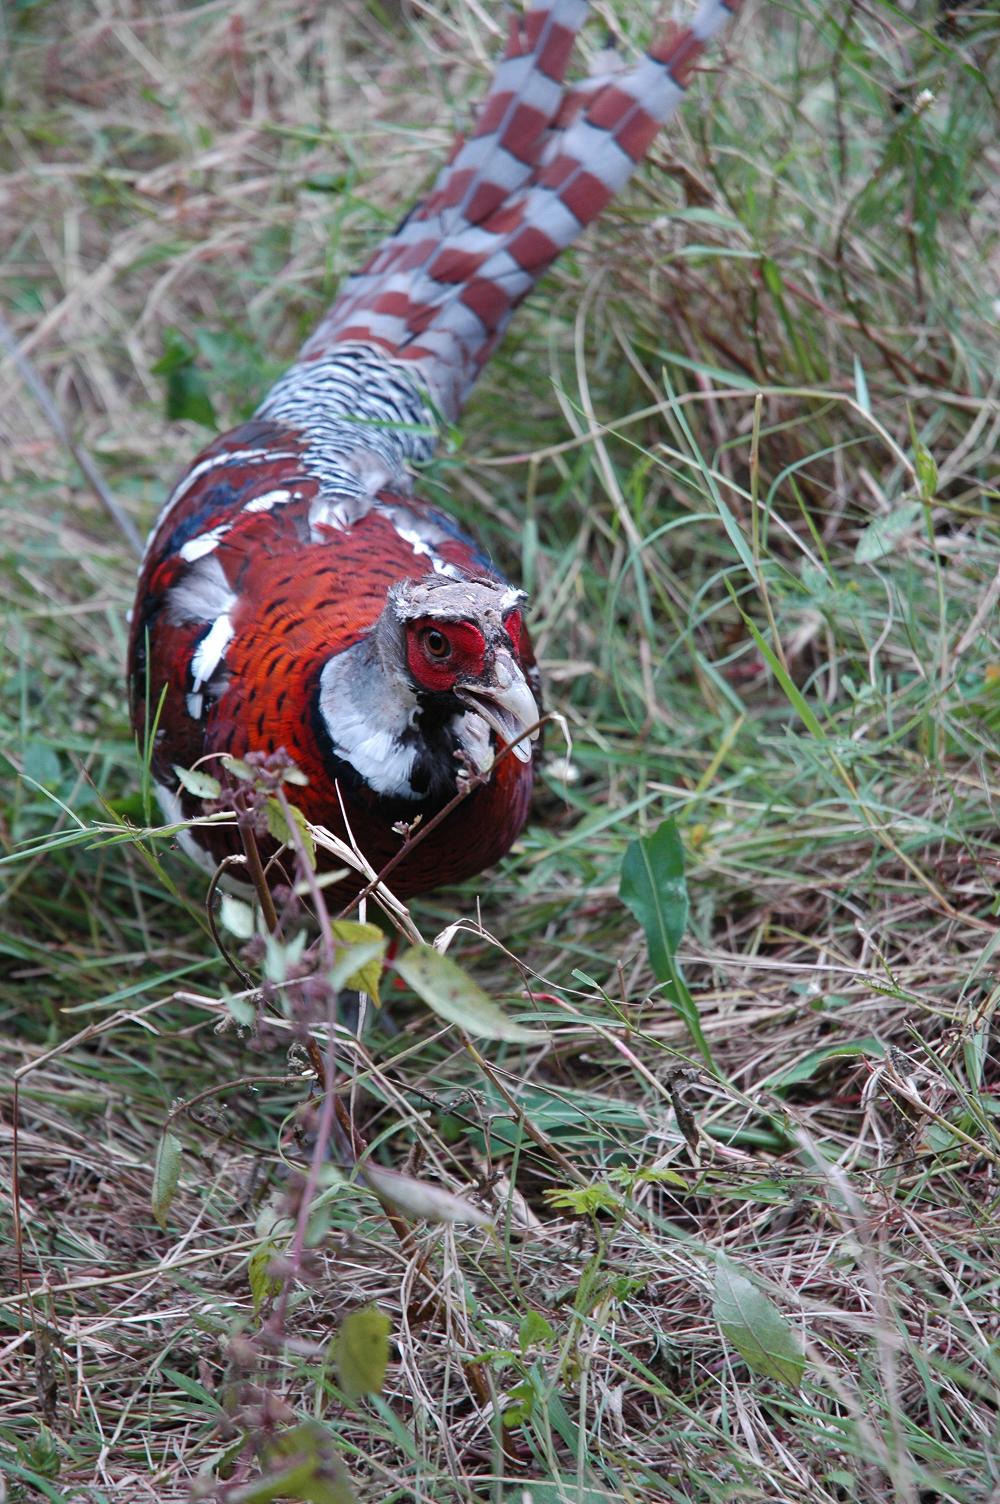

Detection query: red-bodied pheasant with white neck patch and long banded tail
(129, 0), (738, 896)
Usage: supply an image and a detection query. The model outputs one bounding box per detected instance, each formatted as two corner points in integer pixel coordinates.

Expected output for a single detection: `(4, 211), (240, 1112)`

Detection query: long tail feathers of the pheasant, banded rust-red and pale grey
(293, 0), (740, 420)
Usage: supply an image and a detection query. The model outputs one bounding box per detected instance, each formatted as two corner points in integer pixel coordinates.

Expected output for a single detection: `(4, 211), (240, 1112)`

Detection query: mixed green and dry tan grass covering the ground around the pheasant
(0, 0), (1000, 1504)
